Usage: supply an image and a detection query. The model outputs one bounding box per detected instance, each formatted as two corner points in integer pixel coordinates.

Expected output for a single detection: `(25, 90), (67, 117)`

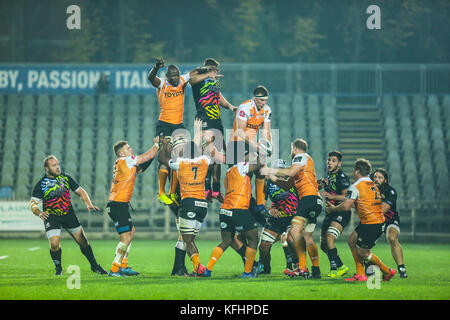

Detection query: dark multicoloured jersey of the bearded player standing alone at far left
(31, 173), (80, 216)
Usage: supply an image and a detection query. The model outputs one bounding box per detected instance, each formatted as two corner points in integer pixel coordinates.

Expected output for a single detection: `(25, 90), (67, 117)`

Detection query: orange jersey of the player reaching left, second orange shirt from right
(292, 153), (319, 200)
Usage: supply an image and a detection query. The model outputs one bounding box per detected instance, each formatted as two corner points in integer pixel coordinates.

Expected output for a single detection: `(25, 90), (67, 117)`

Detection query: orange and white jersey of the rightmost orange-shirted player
(347, 177), (384, 224)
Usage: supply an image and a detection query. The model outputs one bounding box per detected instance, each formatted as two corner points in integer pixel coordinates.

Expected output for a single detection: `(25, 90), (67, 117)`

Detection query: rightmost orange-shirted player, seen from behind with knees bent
(325, 159), (396, 281)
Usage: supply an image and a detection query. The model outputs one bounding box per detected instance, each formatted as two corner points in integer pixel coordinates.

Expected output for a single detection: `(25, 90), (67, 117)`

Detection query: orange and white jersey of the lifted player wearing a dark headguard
(231, 99), (272, 141)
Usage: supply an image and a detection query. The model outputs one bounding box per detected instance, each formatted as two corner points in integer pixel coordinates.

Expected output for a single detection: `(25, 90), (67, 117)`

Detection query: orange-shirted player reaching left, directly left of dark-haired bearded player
(260, 139), (323, 278)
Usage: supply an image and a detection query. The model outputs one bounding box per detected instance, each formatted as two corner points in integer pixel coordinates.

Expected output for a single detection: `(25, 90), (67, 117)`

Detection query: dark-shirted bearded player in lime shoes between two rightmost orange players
(318, 150), (351, 278)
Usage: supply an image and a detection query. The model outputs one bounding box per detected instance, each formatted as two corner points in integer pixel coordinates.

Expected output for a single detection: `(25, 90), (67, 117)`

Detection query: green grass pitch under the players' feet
(0, 235), (450, 300)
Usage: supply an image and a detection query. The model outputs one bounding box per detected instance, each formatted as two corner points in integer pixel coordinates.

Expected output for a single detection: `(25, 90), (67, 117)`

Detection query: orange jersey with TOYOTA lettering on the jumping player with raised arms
(157, 73), (190, 124)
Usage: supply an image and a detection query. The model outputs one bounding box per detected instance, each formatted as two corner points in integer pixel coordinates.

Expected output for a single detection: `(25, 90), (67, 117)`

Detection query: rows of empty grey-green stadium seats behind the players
(0, 93), (450, 215)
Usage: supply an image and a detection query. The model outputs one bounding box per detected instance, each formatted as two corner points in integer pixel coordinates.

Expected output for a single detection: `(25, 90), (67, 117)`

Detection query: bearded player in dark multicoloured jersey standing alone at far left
(30, 155), (107, 275)
